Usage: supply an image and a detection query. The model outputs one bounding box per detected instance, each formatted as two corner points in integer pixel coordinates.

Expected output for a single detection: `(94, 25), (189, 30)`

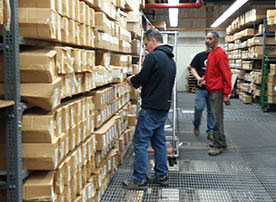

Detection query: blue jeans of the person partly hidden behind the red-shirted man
(193, 88), (214, 134)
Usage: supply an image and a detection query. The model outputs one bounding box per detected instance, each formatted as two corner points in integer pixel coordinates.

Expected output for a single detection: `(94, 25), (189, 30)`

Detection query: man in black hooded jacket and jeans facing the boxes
(123, 29), (176, 189)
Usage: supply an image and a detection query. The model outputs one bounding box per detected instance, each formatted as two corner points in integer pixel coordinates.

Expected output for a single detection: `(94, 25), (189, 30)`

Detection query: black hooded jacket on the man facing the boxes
(131, 45), (176, 110)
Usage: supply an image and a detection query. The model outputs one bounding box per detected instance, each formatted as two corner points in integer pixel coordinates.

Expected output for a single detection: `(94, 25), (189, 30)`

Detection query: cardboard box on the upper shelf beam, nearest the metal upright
(18, 8), (57, 40)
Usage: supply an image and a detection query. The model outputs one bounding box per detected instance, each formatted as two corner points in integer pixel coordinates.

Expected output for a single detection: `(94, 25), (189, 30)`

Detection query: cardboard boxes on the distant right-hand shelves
(225, 9), (276, 103)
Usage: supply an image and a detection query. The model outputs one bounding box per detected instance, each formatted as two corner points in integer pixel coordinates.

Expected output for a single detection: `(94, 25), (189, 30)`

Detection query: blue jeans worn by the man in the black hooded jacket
(132, 108), (168, 182)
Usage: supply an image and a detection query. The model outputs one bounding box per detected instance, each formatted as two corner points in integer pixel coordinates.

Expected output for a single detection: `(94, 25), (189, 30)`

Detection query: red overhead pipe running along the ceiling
(145, 0), (203, 9)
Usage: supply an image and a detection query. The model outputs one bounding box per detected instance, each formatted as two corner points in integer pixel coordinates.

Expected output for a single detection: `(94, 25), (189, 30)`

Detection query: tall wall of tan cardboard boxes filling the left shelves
(0, 0), (144, 202)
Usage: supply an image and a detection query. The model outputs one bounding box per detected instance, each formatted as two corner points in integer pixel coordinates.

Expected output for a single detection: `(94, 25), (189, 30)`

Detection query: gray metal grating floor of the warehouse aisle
(101, 93), (276, 202)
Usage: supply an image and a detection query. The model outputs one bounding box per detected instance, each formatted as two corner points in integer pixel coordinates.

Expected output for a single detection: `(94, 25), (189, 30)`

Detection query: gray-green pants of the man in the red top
(209, 92), (226, 148)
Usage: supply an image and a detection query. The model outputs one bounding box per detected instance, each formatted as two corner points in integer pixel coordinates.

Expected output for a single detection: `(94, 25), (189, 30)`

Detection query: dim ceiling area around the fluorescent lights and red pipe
(144, 0), (275, 31)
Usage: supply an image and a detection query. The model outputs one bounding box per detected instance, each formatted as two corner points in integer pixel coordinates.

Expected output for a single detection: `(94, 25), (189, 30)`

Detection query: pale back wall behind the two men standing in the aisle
(176, 31), (225, 91)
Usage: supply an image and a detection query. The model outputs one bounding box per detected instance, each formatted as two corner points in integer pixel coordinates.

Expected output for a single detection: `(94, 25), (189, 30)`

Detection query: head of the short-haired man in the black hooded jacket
(144, 29), (163, 52)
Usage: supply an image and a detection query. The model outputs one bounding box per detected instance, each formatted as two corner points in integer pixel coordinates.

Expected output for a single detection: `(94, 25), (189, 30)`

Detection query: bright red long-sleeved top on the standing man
(204, 47), (232, 97)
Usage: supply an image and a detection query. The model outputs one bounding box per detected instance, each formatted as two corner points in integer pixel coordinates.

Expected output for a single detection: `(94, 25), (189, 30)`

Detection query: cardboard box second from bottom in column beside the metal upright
(22, 138), (59, 170)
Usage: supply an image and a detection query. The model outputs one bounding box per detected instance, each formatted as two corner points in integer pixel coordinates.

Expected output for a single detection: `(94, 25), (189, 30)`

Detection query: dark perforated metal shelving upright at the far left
(0, 0), (25, 202)
